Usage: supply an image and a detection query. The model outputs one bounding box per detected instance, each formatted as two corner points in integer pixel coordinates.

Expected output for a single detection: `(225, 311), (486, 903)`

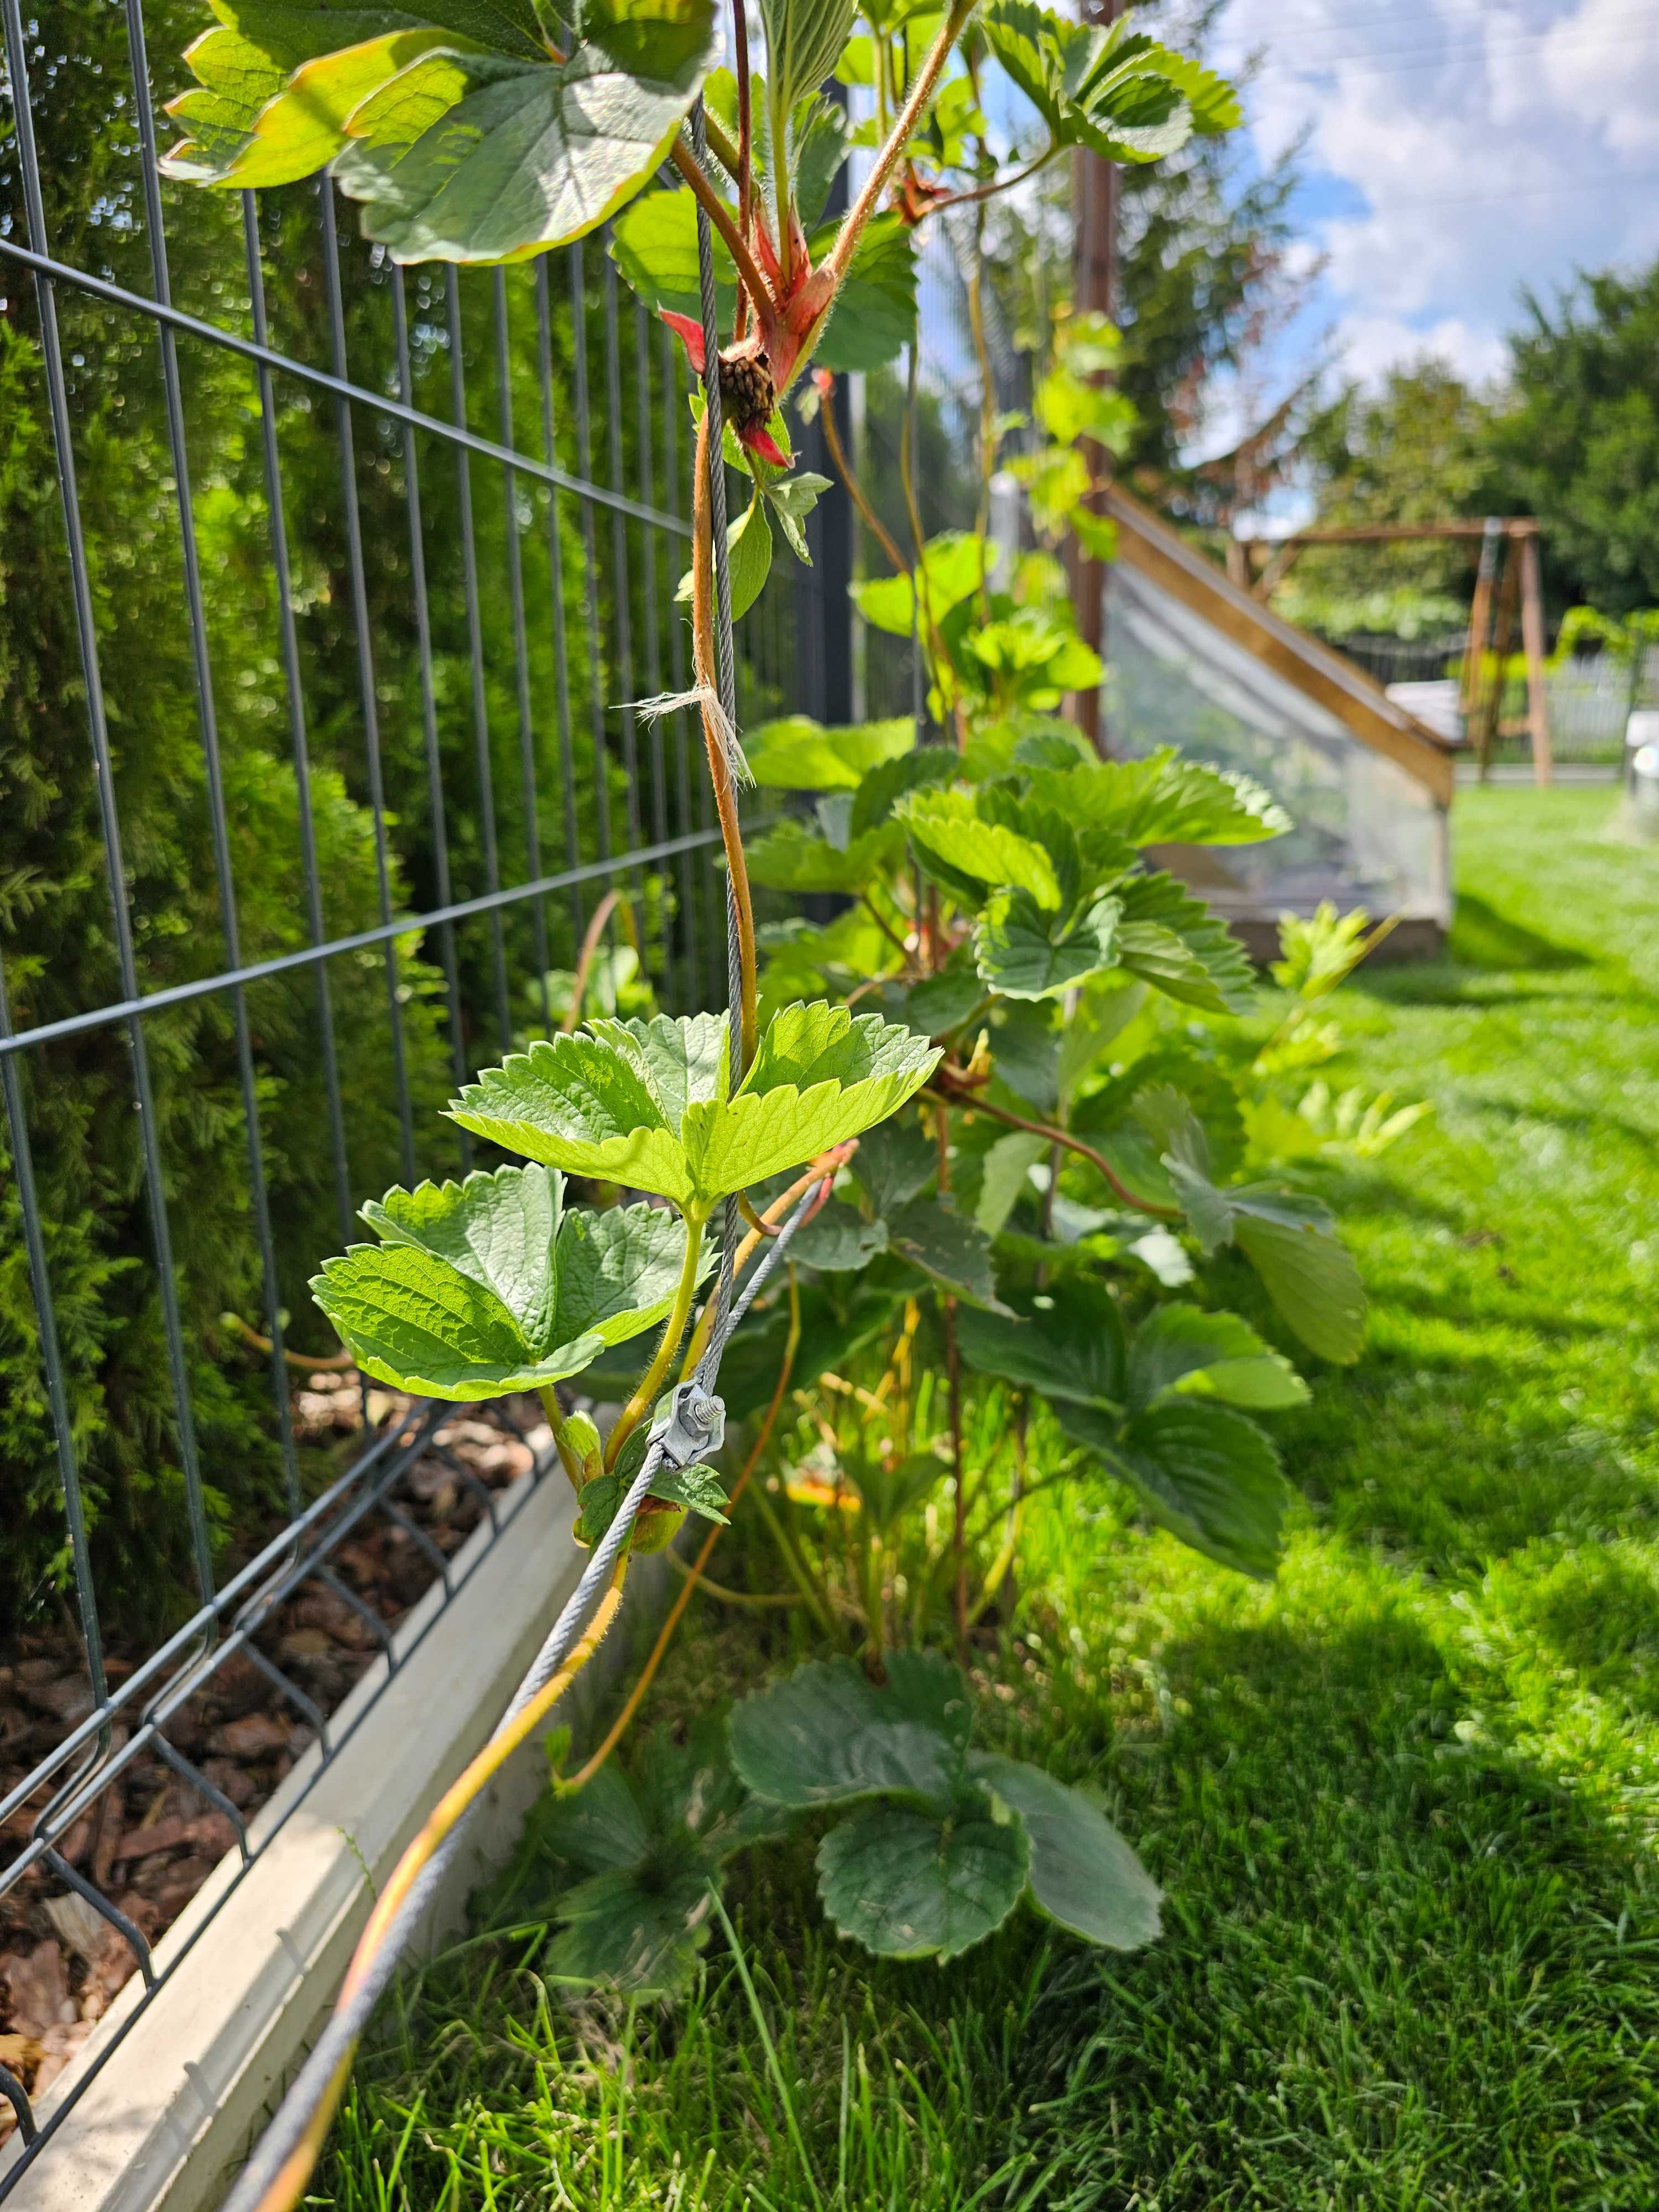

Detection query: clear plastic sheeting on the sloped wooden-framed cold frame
(1102, 560), (1451, 929)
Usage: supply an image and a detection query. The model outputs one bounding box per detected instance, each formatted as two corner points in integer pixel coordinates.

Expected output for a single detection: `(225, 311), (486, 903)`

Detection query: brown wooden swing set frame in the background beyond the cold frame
(1228, 515), (1555, 783)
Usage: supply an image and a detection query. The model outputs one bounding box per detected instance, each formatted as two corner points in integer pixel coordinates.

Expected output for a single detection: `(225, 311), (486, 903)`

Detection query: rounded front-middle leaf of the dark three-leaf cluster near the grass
(818, 1792), (1031, 1964)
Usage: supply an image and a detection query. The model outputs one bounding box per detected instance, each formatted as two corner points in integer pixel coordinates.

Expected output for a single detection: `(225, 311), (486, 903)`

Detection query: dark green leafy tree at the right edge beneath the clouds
(1493, 261), (1659, 615)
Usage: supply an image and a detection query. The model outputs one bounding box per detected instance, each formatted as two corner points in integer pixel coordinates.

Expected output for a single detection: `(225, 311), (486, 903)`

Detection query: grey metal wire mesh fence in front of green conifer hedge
(0, 0), (827, 2197)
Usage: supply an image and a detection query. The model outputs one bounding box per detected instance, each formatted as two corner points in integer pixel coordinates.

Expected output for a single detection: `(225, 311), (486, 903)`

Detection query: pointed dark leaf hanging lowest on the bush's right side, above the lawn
(1055, 1396), (1290, 1577)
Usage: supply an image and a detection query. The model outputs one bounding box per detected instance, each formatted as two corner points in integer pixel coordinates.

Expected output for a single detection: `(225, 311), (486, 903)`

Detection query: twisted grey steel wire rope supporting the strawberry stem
(223, 100), (783, 2212)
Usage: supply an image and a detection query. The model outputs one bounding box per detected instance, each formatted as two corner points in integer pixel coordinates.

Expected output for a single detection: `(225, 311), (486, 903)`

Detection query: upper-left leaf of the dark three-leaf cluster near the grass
(732, 1652), (969, 1807)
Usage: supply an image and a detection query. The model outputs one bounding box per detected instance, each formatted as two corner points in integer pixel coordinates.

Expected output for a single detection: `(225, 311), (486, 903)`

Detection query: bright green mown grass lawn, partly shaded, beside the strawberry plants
(312, 790), (1659, 2212)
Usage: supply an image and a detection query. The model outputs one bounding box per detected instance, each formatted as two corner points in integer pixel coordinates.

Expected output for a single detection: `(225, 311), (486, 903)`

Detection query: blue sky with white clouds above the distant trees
(1208, 0), (1659, 407)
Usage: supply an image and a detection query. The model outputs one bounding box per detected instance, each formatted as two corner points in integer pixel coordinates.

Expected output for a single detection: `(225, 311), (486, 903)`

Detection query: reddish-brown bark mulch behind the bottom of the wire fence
(0, 1371), (555, 2143)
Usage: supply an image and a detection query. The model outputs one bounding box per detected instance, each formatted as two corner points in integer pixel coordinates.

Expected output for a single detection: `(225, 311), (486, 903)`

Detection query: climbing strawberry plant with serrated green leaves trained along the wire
(168, 0), (1380, 2208)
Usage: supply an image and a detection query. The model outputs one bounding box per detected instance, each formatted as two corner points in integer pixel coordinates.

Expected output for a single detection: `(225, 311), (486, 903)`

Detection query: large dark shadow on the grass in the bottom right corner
(1015, 1597), (1659, 2212)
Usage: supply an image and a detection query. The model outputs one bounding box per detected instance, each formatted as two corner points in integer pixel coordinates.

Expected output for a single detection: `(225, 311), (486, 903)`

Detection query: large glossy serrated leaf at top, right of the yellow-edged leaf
(334, 0), (717, 261)
